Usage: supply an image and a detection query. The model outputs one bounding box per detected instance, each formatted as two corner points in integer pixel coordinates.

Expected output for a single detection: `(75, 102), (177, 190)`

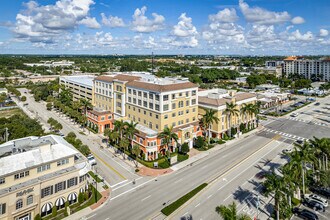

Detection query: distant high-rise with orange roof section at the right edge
(284, 56), (330, 81)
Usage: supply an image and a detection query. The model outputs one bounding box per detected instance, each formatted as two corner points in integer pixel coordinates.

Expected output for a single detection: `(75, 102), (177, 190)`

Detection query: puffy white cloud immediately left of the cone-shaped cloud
(131, 6), (165, 33)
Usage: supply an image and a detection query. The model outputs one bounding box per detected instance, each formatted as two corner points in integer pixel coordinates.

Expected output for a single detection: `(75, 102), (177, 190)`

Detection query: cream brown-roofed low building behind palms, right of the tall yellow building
(198, 89), (257, 138)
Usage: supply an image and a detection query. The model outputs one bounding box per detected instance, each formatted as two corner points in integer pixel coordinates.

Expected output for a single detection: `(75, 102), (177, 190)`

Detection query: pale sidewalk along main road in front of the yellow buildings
(171, 125), (263, 171)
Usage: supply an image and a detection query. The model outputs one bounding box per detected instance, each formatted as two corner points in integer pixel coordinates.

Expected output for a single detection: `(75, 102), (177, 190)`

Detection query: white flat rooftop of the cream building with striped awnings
(0, 135), (80, 176)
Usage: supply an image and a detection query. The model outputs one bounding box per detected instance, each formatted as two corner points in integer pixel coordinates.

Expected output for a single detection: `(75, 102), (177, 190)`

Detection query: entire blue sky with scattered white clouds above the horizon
(0, 0), (330, 55)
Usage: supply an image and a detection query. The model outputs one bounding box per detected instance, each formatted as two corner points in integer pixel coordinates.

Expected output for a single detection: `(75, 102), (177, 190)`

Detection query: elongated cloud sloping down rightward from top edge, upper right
(239, 0), (291, 25)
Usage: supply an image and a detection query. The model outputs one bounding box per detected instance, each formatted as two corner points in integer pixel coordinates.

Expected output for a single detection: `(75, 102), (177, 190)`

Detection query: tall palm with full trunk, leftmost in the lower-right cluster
(263, 171), (284, 219)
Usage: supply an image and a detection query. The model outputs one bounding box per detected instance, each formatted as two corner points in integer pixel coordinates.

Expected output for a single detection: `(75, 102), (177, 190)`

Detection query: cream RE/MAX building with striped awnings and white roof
(0, 135), (89, 220)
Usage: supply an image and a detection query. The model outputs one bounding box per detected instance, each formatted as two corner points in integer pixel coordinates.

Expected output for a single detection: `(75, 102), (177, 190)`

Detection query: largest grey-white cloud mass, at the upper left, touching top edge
(13, 0), (97, 43)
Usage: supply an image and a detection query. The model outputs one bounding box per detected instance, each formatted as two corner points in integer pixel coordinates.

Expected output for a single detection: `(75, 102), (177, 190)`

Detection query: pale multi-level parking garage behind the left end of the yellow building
(60, 75), (95, 101)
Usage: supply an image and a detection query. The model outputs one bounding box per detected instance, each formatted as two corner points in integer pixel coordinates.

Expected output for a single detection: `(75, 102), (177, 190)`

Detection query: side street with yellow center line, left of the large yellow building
(14, 88), (142, 186)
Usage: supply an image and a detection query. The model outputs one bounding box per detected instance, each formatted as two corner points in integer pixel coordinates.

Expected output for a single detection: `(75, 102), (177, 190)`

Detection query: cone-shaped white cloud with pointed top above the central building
(172, 13), (198, 37)
